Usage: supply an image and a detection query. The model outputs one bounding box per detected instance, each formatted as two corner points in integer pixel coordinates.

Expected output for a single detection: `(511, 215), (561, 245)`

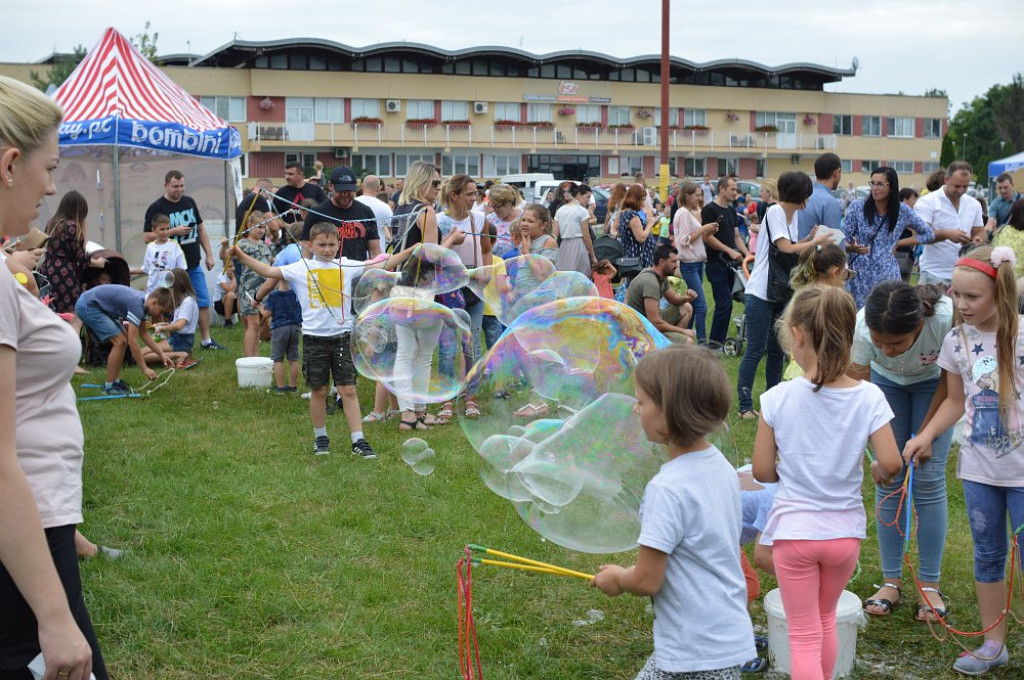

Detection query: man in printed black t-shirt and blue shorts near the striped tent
(142, 170), (225, 349)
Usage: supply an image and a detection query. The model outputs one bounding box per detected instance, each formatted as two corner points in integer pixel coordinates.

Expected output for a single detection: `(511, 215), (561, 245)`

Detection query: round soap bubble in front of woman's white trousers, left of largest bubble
(352, 297), (471, 405)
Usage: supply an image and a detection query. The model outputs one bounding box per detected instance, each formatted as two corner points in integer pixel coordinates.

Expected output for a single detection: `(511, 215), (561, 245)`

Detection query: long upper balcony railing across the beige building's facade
(240, 122), (836, 154)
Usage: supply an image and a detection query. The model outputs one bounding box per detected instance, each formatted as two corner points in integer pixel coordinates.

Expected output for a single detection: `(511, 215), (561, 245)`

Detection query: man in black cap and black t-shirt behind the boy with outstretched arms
(302, 167), (381, 261)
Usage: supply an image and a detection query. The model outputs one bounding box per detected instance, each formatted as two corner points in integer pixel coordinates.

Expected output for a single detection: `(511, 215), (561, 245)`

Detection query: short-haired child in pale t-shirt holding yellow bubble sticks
(592, 345), (757, 680)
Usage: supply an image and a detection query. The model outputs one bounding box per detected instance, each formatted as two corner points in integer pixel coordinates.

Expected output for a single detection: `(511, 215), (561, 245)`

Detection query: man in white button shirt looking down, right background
(913, 161), (985, 286)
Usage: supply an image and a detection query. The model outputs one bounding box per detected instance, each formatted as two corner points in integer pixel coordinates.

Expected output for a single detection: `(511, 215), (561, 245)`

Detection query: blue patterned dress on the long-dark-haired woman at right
(843, 199), (935, 309)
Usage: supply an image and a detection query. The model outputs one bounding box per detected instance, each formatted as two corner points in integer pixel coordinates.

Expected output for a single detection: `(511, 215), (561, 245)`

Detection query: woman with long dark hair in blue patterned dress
(843, 167), (956, 309)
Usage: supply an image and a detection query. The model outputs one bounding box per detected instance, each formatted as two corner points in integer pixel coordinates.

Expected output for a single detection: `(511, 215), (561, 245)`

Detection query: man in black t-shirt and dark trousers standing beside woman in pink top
(700, 177), (749, 345)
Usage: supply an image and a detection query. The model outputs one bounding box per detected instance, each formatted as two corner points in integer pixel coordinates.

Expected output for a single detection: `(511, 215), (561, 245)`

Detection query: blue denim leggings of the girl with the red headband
(964, 479), (1024, 583)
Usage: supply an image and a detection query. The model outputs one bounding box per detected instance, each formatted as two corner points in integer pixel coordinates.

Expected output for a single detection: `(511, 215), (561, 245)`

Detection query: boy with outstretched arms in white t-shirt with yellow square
(229, 222), (381, 459)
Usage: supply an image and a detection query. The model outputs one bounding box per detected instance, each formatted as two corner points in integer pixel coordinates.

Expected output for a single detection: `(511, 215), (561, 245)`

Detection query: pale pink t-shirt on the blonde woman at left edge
(0, 256), (85, 528)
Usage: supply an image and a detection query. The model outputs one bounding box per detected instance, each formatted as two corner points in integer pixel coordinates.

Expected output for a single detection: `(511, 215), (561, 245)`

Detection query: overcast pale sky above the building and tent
(0, 0), (1024, 111)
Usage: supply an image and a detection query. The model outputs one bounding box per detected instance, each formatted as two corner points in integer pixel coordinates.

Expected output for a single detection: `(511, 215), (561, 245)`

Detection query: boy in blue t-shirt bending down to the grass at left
(72, 284), (174, 394)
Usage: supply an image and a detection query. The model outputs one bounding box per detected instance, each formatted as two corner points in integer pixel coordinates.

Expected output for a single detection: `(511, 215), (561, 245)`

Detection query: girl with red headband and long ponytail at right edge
(903, 246), (1024, 675)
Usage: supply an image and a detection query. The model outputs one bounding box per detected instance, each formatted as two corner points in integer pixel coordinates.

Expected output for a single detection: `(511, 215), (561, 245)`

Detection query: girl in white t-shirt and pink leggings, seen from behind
(754, 286), (902, 680)
